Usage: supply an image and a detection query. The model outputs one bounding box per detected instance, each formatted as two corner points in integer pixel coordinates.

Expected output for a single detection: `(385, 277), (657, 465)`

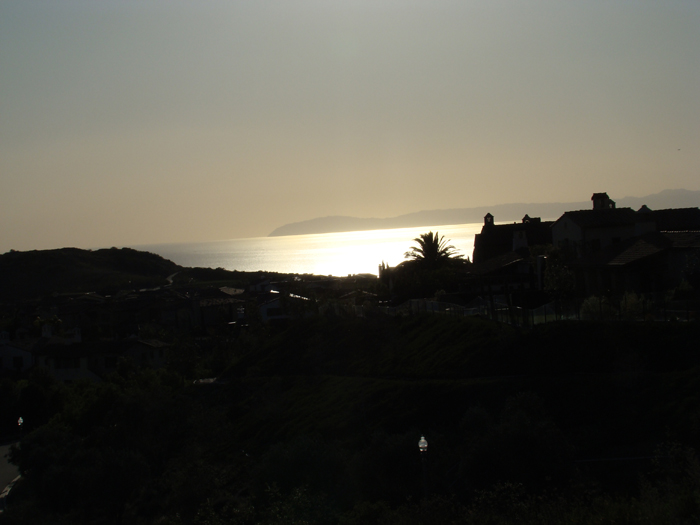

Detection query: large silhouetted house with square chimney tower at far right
(552, 193), (700, 297)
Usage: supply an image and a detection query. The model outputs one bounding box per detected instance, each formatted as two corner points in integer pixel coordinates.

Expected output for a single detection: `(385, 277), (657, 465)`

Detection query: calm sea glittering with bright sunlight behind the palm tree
(135, 223), (482, 276)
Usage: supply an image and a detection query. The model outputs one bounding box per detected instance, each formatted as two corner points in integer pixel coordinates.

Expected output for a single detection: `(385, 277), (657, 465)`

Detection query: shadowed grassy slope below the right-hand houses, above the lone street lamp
(220, 317), (700, 457)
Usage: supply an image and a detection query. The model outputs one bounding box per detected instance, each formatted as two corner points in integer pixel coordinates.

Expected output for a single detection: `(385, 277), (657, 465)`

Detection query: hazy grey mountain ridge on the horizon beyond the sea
(268, 189), (700, 237)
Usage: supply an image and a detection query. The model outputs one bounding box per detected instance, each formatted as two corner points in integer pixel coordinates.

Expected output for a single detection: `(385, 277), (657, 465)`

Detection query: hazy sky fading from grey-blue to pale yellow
(0, 0), (700, 253)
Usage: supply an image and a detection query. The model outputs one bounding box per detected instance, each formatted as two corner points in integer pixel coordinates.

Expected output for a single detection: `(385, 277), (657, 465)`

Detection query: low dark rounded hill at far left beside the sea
(0, 248), (181, 300)
